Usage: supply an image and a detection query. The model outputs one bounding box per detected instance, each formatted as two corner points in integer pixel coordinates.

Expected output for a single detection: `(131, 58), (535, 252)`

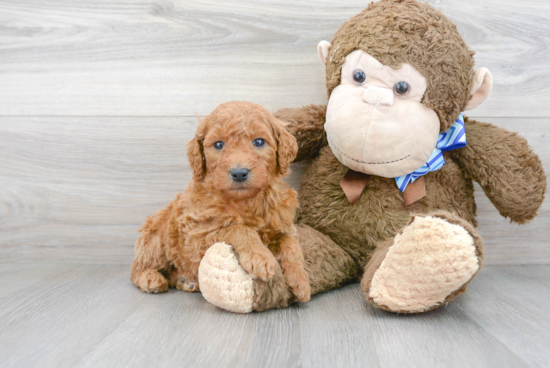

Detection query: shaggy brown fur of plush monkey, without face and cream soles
(216, 0), (546, 310)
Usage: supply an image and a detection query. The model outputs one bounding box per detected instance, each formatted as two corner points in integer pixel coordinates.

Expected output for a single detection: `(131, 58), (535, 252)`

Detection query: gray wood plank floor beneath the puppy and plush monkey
(0, 264), (550, 367)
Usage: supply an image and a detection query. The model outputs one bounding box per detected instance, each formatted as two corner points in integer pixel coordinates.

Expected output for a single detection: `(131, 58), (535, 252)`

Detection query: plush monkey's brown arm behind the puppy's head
(273, 105), (328, 162)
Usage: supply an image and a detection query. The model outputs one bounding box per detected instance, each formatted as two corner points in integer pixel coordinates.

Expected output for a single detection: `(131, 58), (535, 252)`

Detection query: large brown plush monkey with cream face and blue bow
(199, 0), (546, 313)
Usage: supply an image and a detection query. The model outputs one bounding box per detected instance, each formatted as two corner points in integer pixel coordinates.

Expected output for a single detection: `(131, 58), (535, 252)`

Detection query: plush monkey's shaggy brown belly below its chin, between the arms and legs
(297, 147), (476, 267)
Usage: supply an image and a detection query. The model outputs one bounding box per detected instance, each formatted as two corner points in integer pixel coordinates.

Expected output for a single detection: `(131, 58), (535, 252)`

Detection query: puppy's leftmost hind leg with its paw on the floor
(130, 233), (169, 294)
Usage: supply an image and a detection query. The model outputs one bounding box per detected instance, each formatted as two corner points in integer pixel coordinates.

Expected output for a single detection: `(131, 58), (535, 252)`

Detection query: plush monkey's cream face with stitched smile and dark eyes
(325, 50), (440, 178)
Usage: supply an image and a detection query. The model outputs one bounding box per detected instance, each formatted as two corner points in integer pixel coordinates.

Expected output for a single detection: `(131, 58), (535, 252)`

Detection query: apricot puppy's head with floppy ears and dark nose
(188, 102), (297, 199)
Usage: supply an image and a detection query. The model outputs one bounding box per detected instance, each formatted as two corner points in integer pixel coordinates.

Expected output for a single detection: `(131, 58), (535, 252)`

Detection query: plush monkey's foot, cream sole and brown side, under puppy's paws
(199, 243), (296, 313)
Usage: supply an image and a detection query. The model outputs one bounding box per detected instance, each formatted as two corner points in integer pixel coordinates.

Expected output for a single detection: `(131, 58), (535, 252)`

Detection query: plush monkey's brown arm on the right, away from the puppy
(449, 119), (546, 224)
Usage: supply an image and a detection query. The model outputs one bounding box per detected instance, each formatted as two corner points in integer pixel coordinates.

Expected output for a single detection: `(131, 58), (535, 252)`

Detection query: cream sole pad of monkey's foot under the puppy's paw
(199, 243), (254, 313)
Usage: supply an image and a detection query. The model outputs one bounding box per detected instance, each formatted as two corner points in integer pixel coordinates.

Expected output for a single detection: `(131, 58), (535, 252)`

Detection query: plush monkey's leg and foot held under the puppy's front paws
(199, 225), (358, 313)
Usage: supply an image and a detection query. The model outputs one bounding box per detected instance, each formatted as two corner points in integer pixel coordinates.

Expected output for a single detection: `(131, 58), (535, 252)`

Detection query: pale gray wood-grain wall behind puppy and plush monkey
(0, 0), (550, 264)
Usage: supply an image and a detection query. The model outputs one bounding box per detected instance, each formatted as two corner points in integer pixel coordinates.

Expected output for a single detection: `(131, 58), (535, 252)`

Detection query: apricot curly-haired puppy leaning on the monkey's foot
(131, 102), (311, 302)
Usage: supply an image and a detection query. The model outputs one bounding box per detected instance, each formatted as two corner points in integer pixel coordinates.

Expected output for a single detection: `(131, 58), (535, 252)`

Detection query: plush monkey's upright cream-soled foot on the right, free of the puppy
(361, 211), (483, 313)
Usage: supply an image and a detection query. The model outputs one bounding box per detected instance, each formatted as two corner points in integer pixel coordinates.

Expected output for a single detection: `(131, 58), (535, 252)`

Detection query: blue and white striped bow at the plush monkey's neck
(395, 113), (466, 192)
